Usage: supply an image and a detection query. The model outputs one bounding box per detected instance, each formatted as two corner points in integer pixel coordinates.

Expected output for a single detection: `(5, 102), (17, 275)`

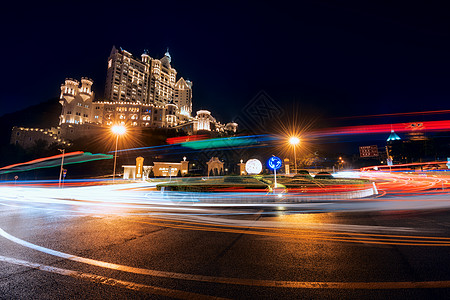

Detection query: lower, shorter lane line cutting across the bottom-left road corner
(0, 256), (225, 299)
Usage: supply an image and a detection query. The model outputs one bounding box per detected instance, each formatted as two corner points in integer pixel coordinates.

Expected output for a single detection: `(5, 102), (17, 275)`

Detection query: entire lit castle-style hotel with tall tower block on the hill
(60, 47), (237, 134)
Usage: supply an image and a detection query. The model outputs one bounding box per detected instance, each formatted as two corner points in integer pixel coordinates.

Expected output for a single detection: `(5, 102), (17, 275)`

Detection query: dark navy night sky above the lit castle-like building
(0, 0), (450, 122)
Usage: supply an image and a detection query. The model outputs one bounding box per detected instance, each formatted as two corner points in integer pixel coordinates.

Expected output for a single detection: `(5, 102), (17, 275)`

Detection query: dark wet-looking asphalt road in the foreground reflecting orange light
(0, 176), (450, 299)
